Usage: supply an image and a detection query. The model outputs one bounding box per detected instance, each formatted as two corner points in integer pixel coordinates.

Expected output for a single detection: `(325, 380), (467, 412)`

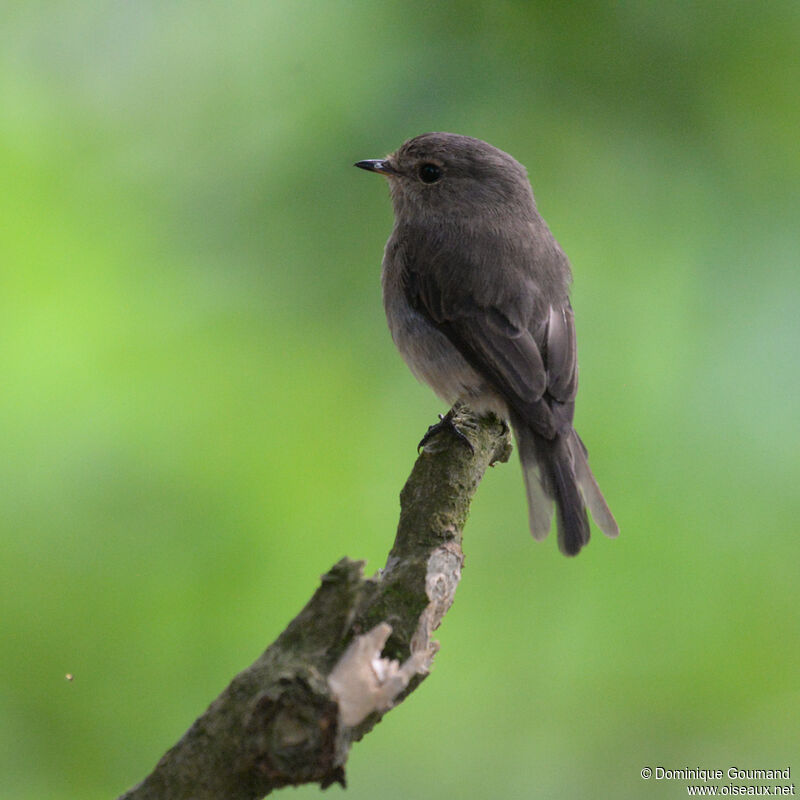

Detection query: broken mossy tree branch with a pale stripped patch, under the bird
(120, 406), (511, 800)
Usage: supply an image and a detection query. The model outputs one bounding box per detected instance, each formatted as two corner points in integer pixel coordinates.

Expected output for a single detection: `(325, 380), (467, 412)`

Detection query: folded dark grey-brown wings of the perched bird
(404, 250), (577, 439)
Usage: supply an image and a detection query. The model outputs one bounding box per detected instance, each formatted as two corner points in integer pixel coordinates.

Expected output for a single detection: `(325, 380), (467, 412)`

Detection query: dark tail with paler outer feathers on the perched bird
(512, 419), (619, 556)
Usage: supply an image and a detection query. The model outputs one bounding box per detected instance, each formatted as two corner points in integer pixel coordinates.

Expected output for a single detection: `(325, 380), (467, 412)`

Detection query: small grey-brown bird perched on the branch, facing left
(356, 133), (618, 555)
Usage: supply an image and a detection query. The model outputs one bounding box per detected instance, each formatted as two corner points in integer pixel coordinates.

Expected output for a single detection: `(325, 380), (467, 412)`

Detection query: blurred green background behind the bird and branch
(0, 0), (800, 800)
